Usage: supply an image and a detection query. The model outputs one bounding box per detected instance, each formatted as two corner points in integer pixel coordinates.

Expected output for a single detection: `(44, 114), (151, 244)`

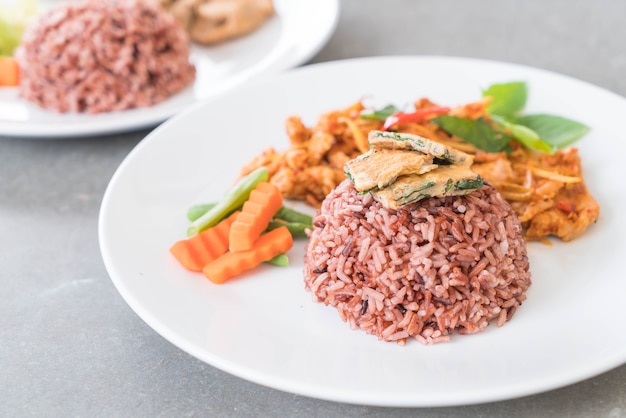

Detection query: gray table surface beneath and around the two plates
(0, 0), (626, 418)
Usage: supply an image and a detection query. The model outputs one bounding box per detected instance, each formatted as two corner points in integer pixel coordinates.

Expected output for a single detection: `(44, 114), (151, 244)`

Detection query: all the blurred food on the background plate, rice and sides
(0, 0), (275, 105)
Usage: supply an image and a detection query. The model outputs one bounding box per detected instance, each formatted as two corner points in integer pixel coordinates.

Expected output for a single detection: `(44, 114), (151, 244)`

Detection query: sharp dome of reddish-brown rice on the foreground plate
(304, 180), (531, 344)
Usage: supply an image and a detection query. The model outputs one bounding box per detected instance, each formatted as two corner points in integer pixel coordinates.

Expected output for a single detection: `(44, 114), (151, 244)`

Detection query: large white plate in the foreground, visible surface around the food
(99, 57), (626, 406)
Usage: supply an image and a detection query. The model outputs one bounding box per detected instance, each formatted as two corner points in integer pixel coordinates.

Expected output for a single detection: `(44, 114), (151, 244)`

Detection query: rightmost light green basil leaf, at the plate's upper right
(515, 114), (589, 149)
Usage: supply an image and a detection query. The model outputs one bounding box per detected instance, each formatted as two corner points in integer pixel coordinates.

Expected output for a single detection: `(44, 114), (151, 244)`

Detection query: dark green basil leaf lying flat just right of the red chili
(432, 115), (511, 152)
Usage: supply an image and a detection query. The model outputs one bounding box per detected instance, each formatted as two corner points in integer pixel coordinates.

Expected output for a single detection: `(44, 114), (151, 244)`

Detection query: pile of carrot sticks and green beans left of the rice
(170, 167), (313, 283)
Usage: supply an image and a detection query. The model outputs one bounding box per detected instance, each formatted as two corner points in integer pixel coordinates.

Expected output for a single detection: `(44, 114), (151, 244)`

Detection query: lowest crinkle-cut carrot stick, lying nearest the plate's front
(202, 226), (293, 284)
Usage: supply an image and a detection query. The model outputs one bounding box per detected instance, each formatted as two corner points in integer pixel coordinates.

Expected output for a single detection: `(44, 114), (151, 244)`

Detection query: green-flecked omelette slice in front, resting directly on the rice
(370, 165), (484, 209)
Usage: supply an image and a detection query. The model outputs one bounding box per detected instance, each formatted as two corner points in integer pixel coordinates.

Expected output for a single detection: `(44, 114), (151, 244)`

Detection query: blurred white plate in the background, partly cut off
(0, 0), (339, 138)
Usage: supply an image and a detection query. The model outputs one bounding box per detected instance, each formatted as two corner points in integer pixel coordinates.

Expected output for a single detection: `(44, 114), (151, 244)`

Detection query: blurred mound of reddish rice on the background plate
(16, 0), (196, 113)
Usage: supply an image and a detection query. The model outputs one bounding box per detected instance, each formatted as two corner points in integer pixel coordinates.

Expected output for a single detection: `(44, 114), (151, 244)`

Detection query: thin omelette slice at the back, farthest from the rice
(368, 131), (474, 166)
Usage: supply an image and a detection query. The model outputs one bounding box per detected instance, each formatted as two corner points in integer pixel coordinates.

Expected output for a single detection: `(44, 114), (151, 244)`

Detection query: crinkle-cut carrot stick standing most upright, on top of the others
(228, 182), (283, 251)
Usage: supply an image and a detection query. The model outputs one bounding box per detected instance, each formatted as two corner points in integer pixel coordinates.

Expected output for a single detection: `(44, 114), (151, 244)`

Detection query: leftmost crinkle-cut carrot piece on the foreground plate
(170, 212), (239, 271)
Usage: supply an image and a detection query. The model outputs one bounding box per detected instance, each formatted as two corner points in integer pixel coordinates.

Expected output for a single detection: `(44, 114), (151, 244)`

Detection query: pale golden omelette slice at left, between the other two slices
(344, 149), (437, 192)
